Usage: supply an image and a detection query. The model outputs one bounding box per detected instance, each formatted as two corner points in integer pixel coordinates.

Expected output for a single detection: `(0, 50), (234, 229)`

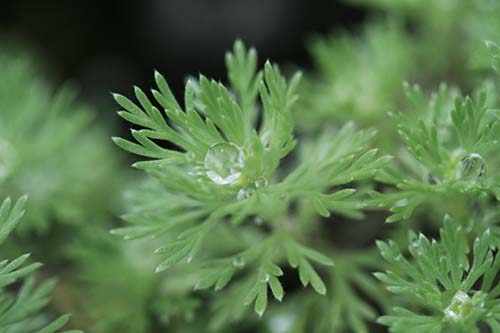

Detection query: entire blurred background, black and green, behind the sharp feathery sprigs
(0, 0), (500, 333)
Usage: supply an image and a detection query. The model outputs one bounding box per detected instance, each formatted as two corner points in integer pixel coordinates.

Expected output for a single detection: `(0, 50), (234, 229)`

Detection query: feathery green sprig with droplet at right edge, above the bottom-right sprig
(372, 85), (500, 222)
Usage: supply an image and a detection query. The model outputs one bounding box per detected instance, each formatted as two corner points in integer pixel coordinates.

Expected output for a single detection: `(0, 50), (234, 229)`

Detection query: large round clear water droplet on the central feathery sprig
(205, 142), (245, 185)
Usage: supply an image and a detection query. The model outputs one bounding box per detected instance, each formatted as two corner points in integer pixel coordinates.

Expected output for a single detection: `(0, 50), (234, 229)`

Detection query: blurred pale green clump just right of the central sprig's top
(296, 19), (417, 130)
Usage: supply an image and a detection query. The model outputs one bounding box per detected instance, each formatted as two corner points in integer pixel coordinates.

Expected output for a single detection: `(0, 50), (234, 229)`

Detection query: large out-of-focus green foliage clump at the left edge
(0, 50), (119, 233)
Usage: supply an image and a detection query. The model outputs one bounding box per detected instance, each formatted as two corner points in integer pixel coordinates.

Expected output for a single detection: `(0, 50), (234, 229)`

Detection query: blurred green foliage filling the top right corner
(350, 0), (500, 75)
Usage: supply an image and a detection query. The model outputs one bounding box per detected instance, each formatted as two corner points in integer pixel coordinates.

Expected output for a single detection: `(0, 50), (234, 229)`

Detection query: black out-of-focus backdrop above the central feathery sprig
(0, 0), (365, 112)
